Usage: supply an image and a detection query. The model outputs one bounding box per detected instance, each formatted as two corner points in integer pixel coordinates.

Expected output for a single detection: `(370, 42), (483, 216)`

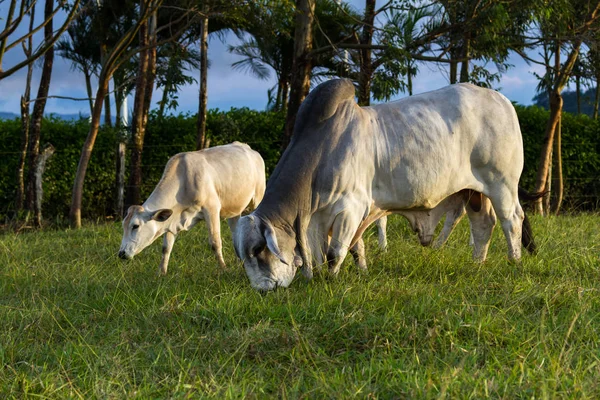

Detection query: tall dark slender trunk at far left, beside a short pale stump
(27, 0), (54, 212)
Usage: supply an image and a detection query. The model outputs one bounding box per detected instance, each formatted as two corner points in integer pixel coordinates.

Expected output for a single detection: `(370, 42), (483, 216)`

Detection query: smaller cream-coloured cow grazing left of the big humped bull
(119, 142), (265, 274)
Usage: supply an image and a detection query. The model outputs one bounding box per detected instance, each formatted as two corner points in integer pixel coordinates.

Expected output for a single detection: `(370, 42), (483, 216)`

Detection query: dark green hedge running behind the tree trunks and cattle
(0, 106), (600, 218)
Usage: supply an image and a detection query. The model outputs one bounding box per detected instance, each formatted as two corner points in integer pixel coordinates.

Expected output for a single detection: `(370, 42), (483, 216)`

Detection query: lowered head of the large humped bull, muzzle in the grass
(234, 214), (302, 291)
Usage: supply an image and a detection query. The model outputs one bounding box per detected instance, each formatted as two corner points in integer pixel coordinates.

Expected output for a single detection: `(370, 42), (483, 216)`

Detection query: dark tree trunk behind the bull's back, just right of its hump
(358, 0), (375, 106)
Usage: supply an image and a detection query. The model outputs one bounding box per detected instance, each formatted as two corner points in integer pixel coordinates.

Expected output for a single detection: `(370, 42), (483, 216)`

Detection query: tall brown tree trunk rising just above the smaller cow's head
(125, 16), (150, 207)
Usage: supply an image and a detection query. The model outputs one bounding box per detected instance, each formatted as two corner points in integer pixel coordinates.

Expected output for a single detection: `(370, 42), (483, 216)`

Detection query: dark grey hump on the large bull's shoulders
(294, 79), (354, 134)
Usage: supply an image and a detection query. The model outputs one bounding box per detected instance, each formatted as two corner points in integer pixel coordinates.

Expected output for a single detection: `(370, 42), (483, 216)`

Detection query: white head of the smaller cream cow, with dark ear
(119, 206), (173, 259)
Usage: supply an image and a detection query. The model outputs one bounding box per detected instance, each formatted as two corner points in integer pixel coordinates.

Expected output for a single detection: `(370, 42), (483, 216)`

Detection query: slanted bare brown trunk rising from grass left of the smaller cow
(69, 78), (109, 228)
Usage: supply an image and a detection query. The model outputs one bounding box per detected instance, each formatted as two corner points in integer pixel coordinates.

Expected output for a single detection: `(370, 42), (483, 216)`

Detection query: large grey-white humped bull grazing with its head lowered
(234, 79), (524, 290)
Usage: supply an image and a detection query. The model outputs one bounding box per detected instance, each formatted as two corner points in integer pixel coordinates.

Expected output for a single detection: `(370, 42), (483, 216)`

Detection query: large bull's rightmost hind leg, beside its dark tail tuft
(490, 187), (525, 262)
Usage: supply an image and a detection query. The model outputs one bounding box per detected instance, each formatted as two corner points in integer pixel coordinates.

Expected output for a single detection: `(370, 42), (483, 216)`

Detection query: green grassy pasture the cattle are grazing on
(0, 215), (600, 399)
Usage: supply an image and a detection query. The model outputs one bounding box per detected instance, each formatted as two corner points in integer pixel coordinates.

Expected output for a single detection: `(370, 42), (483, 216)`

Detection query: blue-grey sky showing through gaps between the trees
(0, 0), (543, 115)
